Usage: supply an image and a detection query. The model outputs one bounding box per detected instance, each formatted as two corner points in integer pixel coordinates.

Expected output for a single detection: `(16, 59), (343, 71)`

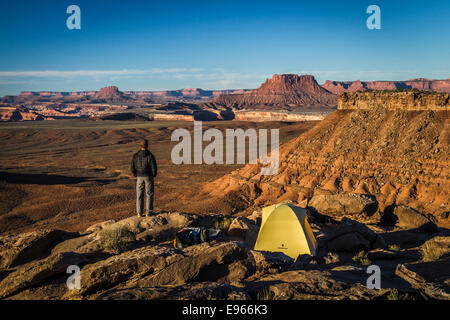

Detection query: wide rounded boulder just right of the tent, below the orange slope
(308, 193), (378, 217)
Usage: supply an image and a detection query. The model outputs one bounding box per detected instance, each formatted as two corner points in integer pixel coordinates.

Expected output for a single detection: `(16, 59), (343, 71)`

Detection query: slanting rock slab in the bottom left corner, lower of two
(0, 252), (86, 299)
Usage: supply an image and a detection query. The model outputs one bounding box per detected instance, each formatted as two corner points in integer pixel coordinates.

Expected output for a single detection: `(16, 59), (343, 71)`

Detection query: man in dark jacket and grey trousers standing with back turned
(131, 139), (158, 217)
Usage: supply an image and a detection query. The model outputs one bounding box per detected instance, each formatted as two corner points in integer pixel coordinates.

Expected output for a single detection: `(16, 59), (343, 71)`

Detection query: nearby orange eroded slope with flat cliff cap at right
(199, 91), (450, 225)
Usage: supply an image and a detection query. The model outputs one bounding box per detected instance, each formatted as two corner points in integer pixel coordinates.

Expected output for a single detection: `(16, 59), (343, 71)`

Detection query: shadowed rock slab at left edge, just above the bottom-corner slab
(0, 229), (77, 269)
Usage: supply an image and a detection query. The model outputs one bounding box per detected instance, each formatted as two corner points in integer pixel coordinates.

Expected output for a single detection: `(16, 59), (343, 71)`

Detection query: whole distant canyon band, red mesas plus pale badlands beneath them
(0, 74), (450, 121)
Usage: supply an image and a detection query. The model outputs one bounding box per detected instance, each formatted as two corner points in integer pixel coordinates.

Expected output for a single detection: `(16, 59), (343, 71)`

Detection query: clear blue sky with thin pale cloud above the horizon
(0, 0), (450, 96)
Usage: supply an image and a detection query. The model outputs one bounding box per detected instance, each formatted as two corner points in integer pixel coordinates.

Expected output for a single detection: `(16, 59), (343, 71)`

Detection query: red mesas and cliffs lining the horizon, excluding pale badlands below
(0, 74), (450, 111)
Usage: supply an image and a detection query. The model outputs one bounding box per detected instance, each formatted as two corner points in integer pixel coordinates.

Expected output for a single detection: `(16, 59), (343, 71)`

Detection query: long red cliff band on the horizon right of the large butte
(322, 78), (450, 94)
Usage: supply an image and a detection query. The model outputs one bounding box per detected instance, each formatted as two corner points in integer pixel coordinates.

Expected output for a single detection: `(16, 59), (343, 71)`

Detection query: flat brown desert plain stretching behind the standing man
(0, 120), (316, 234)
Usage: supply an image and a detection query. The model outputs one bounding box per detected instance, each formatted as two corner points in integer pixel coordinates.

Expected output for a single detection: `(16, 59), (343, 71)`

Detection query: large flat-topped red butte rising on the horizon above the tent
(213, 74), (337, 110)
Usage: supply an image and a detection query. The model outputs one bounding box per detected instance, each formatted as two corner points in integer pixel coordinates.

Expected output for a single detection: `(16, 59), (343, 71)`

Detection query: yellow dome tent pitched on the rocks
(255, 203), (317, 259)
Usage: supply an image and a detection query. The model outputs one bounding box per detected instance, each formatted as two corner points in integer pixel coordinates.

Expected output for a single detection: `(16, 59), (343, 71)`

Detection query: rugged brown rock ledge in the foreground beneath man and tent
(0, 208), (450, 300)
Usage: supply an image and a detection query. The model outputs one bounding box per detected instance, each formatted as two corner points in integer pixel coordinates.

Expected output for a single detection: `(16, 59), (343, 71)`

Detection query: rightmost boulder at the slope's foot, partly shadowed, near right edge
(394, 206), (439, 232)
